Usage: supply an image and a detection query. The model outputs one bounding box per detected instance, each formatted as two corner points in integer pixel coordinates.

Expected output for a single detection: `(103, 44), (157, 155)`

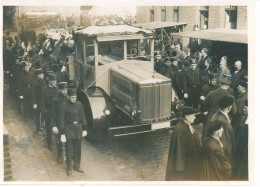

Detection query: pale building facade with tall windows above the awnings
(136, 6), (247, 31)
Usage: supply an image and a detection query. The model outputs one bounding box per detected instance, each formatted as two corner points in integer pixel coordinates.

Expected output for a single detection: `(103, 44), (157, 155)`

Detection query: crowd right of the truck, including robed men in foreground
(161, 43), (248, 181)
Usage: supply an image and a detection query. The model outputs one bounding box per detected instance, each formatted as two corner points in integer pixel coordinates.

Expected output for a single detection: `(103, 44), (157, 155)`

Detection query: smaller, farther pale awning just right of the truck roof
(134, 21), (187, 30)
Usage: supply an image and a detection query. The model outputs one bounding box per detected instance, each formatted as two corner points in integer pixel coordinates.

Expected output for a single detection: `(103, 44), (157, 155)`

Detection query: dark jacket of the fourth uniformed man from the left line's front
(32, 78), (47, 112)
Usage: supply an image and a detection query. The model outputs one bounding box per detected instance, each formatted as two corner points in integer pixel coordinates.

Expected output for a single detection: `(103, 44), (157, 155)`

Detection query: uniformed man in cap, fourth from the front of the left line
(32, 68), (46, 134)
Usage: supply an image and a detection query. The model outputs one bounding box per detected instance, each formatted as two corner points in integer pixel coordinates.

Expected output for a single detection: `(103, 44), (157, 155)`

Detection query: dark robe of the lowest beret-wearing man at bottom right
(201, 137), (231, 181)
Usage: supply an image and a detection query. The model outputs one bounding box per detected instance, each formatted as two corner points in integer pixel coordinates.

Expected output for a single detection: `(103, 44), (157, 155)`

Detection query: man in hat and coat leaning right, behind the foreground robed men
(202, 76), (236, 139)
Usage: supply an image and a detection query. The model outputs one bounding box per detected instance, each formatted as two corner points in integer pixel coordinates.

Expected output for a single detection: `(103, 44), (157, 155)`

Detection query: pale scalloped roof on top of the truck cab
(75, 25), (153, 37)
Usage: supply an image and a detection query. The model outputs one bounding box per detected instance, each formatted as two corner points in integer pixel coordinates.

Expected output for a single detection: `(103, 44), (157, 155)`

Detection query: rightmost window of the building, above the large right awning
(225, 6), (237, 29)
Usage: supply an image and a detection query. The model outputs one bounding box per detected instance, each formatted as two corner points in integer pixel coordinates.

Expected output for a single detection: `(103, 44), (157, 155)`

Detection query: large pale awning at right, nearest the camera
(180, 29), (248, 44)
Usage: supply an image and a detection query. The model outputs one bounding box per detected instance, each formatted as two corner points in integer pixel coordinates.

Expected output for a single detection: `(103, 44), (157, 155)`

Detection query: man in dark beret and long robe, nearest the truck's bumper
(165, 106), (201, 181)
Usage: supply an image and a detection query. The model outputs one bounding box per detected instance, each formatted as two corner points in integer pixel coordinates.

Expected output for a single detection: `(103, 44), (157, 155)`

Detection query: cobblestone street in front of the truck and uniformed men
(4, 84), (177, 181)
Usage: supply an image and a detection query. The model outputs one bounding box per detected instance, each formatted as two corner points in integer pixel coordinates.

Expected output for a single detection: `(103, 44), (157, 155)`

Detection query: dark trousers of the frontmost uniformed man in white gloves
(66, 139), (81, 171)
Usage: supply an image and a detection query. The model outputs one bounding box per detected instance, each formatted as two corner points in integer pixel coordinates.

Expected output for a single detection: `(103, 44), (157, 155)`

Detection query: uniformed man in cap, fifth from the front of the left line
(18, 61), (32, 121)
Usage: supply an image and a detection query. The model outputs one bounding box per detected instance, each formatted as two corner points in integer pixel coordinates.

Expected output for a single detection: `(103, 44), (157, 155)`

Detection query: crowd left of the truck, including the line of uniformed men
(3, 33), (87, 176)
